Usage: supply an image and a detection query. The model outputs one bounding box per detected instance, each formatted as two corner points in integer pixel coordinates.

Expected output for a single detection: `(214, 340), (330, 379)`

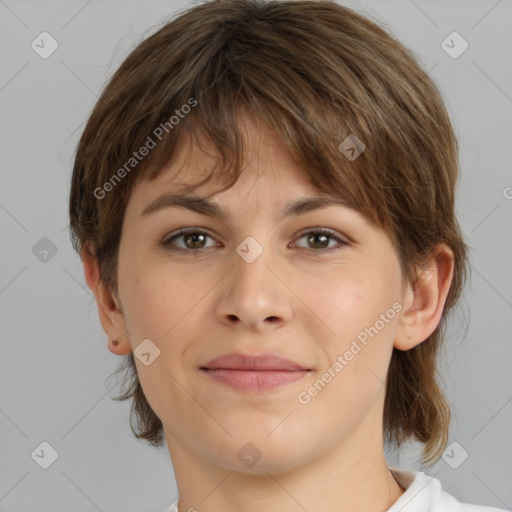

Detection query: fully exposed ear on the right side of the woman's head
(393, 243), (454, 350)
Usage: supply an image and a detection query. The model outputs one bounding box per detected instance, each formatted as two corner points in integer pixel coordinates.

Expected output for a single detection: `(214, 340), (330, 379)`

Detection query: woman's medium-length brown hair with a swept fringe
(69, 0), (469, 463)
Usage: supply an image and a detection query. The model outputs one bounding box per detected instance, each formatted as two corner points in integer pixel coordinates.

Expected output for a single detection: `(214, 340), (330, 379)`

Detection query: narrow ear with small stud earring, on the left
(80, 244), (131, 355)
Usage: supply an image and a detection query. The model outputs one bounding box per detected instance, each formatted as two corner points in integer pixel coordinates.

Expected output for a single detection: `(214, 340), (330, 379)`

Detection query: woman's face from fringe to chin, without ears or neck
(118, 119), (412, 473)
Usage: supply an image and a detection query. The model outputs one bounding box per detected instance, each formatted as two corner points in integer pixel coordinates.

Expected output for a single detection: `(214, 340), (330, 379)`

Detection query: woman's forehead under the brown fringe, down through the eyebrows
(126, 111), (380, 237)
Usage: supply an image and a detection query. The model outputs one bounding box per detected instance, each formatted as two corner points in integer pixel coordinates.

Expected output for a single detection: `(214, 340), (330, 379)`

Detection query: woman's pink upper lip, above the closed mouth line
(201, 352), (309, 371)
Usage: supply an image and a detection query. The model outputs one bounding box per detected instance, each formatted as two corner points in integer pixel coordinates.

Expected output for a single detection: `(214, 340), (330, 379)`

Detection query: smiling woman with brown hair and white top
(70, 0), (508, 512)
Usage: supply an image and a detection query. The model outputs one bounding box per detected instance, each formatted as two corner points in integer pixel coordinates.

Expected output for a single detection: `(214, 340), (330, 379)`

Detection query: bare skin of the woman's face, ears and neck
(82, 117), (453, 512)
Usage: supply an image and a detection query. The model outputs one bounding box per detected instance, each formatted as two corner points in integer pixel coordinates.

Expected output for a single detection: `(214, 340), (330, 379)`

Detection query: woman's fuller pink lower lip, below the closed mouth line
(203, 369), (309, 391)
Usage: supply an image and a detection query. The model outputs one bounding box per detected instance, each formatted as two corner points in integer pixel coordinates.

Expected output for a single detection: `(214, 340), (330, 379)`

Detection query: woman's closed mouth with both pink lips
(199, 353), (311, 392)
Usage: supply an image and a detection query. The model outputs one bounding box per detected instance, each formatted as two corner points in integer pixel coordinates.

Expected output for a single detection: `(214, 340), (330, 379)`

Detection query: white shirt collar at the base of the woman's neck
(164, 468), (510, 512)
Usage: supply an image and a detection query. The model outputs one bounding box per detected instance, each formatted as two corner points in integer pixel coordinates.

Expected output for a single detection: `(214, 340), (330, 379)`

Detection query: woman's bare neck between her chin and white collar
(166, 406), (404, 512)
